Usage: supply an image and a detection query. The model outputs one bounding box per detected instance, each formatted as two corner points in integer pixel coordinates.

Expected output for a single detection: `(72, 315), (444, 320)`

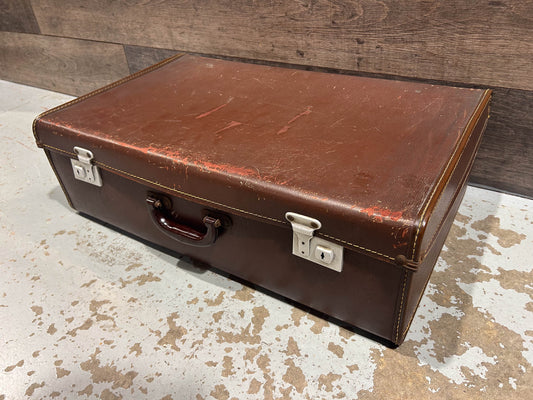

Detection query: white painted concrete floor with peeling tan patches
(0, 81), (533, 400)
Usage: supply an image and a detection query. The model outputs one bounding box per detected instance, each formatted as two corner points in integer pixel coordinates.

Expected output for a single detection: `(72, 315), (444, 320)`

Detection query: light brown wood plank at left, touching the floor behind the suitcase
(0, 32), (129, 95)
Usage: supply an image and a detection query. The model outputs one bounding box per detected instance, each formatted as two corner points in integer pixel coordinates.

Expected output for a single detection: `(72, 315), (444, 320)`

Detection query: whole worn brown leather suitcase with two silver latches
(34, 55), (490, 345)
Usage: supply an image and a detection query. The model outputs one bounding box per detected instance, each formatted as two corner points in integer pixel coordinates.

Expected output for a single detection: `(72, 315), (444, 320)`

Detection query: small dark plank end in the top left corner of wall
(0, 0), (39, 33)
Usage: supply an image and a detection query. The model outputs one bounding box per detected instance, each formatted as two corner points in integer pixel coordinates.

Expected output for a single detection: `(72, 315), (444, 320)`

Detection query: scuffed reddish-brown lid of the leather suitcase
(34, 55), (490, 268)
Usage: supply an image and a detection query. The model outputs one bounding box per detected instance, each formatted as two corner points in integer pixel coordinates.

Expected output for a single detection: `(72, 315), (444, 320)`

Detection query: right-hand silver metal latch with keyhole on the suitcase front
(285, 212), (344, 272)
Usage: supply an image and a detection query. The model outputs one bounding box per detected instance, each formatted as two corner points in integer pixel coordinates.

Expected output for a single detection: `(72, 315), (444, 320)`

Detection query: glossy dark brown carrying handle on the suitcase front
(146, 195), (221, 247)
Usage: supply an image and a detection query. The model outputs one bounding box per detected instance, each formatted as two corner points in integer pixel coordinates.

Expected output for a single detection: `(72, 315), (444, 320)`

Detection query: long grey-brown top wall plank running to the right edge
(32, 0), (533, 89)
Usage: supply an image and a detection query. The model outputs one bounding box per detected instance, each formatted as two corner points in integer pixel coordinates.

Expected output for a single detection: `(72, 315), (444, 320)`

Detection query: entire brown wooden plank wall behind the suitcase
(0, 0), (533, 197)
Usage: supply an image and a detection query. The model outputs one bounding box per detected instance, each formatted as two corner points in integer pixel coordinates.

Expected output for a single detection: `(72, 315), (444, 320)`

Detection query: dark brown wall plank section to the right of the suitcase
(470, 88), (533, 198)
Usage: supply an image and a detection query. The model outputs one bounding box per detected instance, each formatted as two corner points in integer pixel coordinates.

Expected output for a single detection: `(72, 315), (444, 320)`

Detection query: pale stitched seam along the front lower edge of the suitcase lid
(43, 144), (400, 261)
